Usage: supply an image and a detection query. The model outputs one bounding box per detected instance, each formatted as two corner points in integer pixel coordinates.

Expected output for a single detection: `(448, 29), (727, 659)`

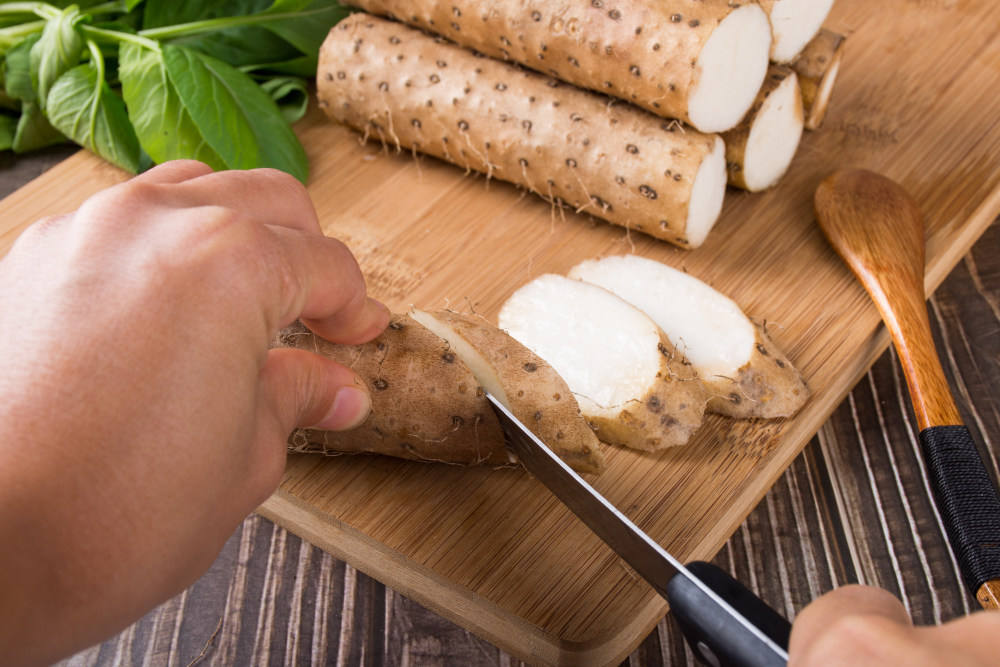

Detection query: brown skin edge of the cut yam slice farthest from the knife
(702, 326), (809, 419)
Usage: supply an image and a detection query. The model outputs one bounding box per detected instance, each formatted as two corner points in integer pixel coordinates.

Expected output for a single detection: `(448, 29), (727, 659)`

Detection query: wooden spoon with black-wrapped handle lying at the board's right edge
(815, 170), (1000, 609)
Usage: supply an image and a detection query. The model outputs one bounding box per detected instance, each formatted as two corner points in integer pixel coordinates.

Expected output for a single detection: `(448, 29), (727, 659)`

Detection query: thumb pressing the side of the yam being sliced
(258, 348), (371, 441)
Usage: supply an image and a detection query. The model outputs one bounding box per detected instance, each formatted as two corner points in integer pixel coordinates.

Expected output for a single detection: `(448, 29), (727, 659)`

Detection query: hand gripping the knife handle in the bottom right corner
(788, 586), (1000, 667)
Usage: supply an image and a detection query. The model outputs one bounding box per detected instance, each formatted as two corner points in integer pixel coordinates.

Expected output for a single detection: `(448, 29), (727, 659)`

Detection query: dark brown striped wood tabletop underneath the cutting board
(0, 148), (1000, 667)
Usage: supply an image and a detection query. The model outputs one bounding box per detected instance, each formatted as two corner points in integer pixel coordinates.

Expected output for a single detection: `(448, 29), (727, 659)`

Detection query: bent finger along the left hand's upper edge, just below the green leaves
(166, 169), (323, 235)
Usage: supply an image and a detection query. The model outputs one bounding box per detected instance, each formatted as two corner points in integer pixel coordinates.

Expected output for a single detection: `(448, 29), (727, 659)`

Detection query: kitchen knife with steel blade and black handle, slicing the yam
(486, 392), (791, 667)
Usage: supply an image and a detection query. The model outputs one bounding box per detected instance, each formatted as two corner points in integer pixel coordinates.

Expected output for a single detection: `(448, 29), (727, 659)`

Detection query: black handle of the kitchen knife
(667, 561), (792, 667)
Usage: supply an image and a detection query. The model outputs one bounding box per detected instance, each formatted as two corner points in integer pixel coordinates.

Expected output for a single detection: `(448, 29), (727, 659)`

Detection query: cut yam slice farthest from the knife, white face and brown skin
(569, 255), (809, 418)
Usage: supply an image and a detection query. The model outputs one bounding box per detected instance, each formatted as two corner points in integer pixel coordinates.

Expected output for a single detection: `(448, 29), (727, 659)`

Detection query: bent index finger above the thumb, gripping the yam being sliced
(259, 228), (389, 344)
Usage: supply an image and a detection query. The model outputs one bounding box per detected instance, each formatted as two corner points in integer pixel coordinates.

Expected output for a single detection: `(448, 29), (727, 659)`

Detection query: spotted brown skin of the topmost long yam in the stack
(348, 0), (752, 127)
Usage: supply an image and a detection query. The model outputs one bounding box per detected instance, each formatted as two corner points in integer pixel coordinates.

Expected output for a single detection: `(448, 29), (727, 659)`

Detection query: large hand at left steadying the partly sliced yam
(0, 162), (389, 664)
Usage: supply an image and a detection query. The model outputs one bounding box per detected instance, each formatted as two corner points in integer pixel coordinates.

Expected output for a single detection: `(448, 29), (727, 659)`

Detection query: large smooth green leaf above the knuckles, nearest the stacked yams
(163, 44), (309, 182)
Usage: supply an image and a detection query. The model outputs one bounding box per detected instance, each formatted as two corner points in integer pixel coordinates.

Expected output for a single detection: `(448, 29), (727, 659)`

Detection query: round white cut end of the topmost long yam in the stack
(688, 4), (772, 132)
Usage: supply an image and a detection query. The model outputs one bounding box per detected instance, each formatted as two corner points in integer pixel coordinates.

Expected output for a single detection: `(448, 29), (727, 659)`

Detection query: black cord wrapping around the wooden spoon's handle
(920, 426), (1000, 594)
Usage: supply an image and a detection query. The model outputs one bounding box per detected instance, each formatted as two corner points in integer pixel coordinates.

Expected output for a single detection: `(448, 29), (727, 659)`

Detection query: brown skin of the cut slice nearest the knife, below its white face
(587, 332), (708, 452)
